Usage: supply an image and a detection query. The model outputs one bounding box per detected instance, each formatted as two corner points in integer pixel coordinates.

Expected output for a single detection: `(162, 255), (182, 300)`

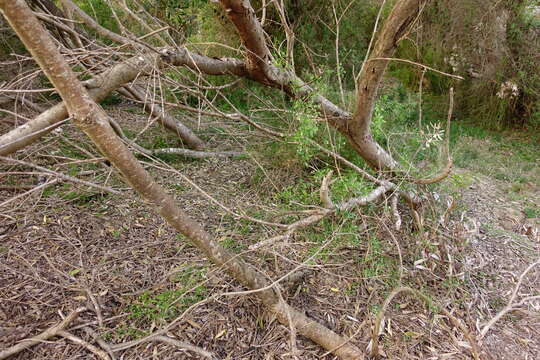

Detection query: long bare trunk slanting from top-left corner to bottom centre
(0, 0), (363, 360)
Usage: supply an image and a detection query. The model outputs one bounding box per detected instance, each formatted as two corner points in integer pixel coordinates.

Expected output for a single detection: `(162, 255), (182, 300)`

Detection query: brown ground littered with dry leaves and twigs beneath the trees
(0, 102), (540, 360)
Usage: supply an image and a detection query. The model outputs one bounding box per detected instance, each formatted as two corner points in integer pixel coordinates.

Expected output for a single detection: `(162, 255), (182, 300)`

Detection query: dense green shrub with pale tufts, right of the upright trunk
(402, 0), (540, 130)
